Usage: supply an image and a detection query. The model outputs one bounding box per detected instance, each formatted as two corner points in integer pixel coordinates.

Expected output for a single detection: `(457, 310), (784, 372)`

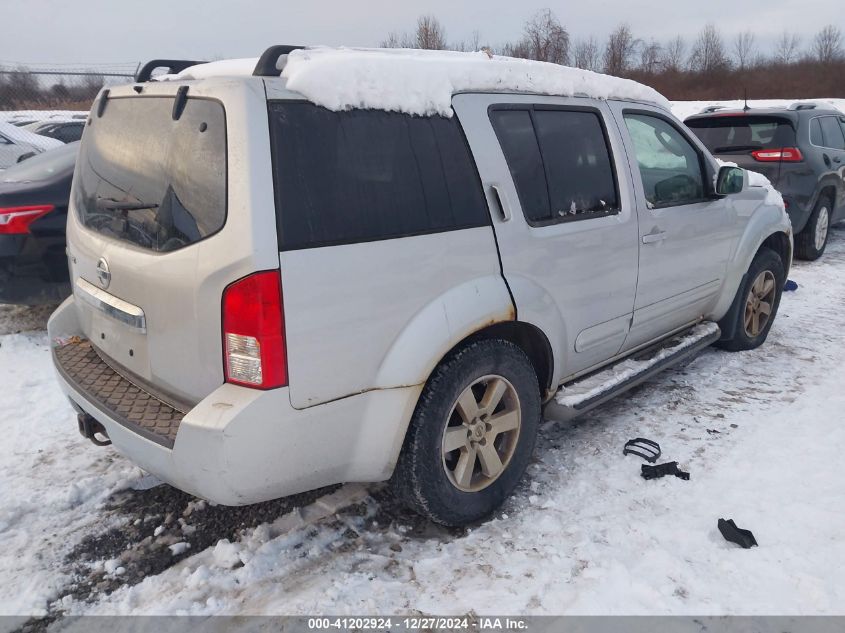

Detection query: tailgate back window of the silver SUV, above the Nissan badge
(74, 97), (226, 252)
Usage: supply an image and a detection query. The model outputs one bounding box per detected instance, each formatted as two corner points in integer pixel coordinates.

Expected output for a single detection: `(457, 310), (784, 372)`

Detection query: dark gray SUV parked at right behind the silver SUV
(685, 103), (845, 260)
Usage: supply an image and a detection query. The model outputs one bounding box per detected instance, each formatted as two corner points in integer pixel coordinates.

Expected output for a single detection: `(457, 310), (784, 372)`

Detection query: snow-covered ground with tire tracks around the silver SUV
(0, 229), (845, 627)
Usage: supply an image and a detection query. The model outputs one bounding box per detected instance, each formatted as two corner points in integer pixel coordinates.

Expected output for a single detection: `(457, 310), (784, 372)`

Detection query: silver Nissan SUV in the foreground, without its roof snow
(49, 48), (792, 525)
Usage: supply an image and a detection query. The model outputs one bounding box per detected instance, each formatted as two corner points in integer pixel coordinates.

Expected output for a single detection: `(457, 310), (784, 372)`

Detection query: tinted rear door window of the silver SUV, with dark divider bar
(490, 107), (619, 226)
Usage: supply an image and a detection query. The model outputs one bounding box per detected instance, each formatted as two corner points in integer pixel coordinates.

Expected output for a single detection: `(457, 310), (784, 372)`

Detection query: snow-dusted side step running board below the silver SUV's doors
(544, 321), (721, 421)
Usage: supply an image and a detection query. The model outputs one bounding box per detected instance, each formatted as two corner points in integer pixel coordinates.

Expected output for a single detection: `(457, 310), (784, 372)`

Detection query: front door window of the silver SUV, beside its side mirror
(625, 113), (705, 207)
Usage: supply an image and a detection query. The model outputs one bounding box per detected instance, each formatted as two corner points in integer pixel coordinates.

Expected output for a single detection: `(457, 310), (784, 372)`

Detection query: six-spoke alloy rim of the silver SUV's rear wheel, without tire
(441, 376), (522, 492)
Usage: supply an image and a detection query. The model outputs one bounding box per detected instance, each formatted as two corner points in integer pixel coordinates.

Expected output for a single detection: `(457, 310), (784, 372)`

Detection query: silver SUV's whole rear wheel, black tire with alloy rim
(391, 339), (540, 526)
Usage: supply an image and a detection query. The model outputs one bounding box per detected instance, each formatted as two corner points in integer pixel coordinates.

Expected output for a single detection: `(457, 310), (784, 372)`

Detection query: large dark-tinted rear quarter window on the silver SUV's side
(269, 101), (490, 250)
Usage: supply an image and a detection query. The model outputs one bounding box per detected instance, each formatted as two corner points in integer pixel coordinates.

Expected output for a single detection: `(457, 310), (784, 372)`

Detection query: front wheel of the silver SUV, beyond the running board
(716, 247), (786, 352)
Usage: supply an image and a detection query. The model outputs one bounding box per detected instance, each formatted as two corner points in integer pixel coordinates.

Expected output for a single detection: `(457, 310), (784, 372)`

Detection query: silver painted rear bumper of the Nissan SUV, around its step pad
(48, 298), (422, 505)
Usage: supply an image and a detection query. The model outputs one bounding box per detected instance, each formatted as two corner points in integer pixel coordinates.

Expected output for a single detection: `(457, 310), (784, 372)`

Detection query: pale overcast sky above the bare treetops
(0, 0), (841, 65)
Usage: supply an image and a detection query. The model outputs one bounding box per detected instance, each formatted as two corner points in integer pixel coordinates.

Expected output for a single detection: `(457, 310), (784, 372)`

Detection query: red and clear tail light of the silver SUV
(223, 270), (288, 389)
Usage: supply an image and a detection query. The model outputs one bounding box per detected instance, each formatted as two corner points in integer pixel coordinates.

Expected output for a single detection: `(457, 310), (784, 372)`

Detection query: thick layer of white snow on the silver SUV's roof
(166, 47), (669, 116)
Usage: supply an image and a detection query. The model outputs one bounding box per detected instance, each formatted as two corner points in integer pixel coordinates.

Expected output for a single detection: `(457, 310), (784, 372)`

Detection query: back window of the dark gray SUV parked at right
(687, 115), (796, 154)
